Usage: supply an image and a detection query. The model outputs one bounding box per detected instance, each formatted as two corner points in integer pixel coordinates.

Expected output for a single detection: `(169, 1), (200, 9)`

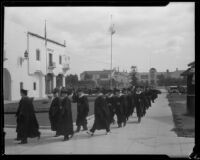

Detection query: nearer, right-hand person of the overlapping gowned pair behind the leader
(57, 88), (74, 141)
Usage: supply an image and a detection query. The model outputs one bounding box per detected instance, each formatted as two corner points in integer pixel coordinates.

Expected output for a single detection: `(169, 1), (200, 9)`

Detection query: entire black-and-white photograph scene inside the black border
(2, 2), (196, 159)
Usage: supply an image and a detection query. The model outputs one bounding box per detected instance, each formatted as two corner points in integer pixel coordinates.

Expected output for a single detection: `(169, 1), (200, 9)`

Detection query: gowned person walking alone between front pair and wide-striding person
(74, 89), (89, 132)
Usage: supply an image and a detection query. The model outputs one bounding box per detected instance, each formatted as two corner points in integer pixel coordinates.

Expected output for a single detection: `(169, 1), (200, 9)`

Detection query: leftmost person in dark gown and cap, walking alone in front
(15, 89), (40, 144)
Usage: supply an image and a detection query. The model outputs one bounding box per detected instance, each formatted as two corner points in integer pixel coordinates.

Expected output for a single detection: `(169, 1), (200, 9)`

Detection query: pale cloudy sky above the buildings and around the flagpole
(5, 2), (195, 75)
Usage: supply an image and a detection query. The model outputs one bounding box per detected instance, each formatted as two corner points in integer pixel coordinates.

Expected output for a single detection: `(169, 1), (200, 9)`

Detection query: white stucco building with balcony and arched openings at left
(3, 21), (69, 101)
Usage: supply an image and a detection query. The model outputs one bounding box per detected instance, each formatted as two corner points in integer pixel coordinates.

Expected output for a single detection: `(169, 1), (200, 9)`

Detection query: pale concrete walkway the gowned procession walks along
(5, 90), (194, 157)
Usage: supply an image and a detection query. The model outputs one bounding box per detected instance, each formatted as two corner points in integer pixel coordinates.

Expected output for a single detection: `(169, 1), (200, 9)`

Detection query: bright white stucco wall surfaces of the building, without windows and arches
(3, 20), (69, 100)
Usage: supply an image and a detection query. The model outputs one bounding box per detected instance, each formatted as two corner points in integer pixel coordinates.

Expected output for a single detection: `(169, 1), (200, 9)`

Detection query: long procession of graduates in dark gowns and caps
(15, 86), (160, 144)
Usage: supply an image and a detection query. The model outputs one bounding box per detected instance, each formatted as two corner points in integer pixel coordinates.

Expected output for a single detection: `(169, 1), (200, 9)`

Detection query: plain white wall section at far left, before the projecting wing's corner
(4, 20), (30, 100)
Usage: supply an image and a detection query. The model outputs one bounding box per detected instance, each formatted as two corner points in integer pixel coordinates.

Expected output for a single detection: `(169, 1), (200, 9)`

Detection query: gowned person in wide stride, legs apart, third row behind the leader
(87, 90), (110, 136)
